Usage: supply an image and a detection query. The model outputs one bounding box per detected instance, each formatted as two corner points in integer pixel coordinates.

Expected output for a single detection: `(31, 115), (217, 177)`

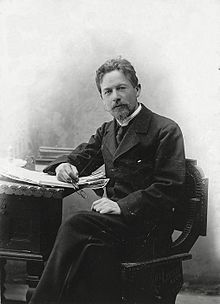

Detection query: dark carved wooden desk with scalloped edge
(0, 180), (64, 303)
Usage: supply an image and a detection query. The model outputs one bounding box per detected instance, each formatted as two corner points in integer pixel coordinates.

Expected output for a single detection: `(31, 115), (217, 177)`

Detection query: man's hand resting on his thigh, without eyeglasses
(91, 197), (121, 214)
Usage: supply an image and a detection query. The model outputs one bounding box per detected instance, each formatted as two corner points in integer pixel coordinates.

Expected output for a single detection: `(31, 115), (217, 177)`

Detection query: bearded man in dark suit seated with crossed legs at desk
(31, 58), (185, 304)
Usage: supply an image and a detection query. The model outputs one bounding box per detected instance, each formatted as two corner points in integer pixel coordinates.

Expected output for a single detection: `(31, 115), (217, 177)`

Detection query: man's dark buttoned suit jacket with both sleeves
(44, 105), (185, 230)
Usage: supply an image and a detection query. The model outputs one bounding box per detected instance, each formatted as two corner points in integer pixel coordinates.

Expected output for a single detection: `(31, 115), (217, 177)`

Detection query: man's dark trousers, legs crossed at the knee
(30, 211), (170, 304)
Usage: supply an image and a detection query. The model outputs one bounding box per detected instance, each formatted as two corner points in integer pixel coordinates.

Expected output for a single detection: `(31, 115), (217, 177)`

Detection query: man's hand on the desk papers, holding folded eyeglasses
(55, 163), (79, 188)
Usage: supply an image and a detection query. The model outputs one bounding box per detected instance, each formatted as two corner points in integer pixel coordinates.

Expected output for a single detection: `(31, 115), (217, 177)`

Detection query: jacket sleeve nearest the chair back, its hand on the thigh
(118, 124), (185, 220)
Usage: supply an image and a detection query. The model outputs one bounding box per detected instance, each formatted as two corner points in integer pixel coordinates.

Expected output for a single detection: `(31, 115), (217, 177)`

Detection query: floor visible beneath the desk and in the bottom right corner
(5, 284), (220, 304)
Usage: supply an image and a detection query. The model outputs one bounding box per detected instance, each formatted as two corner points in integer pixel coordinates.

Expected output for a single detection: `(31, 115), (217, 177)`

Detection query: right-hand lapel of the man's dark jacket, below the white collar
(114, 104), (152, 160)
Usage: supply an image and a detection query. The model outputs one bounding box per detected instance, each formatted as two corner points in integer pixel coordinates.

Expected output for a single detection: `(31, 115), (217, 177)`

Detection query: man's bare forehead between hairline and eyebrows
(100, 70), (131, 90)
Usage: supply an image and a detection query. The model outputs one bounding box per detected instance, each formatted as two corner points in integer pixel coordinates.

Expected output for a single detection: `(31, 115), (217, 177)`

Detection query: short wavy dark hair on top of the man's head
(95, 57), (138, 93)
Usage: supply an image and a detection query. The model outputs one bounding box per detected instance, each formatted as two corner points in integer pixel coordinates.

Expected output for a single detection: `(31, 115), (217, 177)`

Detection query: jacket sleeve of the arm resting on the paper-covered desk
(43, 123), (106, 176)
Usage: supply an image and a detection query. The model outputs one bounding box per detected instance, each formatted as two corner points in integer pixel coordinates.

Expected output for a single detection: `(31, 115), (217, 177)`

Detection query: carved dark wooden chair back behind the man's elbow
(172, 159), (208, 254)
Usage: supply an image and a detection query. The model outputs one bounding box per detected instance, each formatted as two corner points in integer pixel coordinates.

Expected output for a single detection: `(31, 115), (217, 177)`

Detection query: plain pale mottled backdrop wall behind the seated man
(0, 0), (220, 281)
